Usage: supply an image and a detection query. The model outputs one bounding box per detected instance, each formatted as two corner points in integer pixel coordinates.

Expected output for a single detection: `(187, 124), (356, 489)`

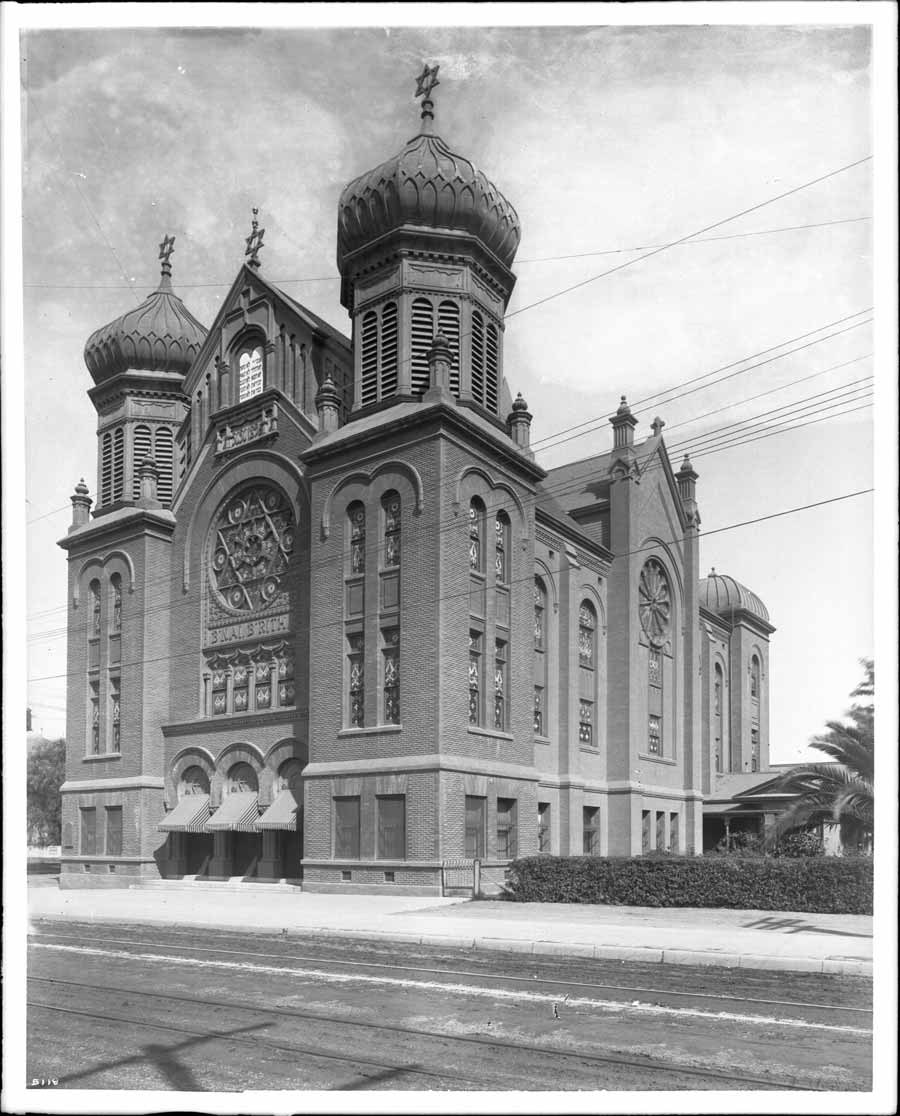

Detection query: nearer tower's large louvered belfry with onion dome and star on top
(337, 66), (520, 429)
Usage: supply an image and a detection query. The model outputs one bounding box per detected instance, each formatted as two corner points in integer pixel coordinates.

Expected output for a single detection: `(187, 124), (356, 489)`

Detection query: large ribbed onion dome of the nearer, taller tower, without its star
(337, 125), (521, 268)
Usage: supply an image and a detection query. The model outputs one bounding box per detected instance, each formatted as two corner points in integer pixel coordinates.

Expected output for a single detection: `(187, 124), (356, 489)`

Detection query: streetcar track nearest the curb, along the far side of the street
(30, 933), (871, 1017)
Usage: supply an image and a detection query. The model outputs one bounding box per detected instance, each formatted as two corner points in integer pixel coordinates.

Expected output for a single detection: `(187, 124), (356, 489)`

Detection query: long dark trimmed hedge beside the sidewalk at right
(505, 856), (872, 914)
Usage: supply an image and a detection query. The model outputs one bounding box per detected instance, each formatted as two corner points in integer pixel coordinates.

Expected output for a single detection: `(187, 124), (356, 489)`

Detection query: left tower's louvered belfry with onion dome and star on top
(85, 237), (207, 516)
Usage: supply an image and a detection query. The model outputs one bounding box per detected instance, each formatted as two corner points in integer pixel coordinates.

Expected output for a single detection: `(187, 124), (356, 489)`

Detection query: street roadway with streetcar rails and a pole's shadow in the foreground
(27, 917), (872, 1091)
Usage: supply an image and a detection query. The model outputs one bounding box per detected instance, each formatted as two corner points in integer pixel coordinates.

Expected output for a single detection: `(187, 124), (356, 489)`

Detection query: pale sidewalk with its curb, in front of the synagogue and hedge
(28, 884), (872, 977)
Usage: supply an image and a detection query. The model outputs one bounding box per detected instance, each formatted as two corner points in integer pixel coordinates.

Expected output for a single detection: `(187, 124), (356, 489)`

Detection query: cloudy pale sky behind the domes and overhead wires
(5, 6), (892, 762)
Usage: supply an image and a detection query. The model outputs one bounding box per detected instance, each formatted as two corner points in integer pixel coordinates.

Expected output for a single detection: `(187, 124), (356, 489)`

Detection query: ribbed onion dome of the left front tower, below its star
(85, 261), (207, 384)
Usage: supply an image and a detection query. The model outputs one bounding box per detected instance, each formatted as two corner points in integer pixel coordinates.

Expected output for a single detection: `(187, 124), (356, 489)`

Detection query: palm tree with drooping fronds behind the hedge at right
(767, 658), (875, 850)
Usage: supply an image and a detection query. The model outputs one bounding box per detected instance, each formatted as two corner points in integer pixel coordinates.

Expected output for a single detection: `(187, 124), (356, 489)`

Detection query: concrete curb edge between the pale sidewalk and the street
(30, 915), (872, 980)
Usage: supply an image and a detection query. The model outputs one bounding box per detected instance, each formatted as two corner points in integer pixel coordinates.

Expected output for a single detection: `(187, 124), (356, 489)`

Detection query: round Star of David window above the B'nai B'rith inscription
(211, 485), (294, 612)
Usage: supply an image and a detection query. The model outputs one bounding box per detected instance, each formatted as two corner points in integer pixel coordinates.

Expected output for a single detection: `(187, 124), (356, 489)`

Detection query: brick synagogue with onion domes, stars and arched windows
(60, 71), (774, 893)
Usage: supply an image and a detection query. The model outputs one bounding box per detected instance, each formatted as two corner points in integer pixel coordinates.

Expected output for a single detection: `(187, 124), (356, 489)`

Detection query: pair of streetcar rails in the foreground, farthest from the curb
(27, 977), (817, 1093)
